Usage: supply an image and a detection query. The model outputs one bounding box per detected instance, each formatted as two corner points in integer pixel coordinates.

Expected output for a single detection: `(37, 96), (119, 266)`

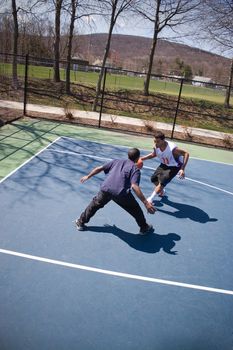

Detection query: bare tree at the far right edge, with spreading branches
(198, 0), (233, 108)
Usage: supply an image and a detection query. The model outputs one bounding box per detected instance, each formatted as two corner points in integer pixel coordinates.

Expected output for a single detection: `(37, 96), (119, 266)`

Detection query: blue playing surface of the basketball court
(0, 138), (233, 350)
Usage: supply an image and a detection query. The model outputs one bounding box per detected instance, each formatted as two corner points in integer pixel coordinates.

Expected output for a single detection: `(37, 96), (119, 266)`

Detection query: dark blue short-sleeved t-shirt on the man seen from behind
(100, 159), (141, 196)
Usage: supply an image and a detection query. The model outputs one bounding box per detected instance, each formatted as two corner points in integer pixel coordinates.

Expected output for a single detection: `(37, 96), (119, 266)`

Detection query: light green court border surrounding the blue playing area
(0, 118), (233, 179)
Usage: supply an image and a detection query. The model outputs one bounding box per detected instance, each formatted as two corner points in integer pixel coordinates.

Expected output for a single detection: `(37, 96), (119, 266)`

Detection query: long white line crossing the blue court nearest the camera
(0, 249), (233, 295)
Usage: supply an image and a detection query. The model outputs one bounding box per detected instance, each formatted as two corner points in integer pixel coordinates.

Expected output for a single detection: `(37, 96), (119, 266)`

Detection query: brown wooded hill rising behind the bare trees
(74, 33), (230, 84)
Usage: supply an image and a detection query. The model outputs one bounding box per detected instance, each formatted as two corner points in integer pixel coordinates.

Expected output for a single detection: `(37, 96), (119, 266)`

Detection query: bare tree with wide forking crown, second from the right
(135, 0), (199, 96)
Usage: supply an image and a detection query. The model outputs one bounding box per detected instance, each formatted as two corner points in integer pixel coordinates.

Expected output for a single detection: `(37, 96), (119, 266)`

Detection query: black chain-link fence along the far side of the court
(0, 54), (233, 144)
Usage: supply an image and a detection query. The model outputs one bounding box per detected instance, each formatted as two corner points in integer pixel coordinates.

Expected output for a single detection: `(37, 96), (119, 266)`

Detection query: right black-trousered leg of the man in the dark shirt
(112, 193), (149, 230)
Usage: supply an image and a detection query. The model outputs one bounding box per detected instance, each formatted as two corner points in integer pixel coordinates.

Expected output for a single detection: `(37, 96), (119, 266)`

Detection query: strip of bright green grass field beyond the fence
(0, 63), (233, 104)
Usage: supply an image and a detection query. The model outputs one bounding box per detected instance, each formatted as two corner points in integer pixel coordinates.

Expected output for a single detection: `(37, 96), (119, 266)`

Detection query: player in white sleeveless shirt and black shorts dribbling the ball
(141, 131), (189, 203)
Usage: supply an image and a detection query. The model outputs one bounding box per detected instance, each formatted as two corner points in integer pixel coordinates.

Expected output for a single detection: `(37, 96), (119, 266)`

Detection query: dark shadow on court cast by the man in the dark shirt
(88, 225), (181, 255)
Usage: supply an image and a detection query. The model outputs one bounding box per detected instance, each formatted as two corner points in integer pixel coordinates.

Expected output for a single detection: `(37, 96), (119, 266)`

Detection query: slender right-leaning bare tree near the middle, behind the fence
(92, 0), (136, 111)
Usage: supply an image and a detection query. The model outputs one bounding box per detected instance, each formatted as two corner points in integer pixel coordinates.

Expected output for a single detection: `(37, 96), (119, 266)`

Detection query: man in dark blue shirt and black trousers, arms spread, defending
(75, 148), (156, 234)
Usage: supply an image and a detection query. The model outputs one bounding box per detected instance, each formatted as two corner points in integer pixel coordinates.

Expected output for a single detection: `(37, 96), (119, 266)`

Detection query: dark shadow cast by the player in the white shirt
(154, 196), (218, 224)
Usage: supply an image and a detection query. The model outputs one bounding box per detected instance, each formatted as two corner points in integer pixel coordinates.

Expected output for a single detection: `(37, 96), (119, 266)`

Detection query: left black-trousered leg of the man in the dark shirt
(77, 191), (112, 225)
